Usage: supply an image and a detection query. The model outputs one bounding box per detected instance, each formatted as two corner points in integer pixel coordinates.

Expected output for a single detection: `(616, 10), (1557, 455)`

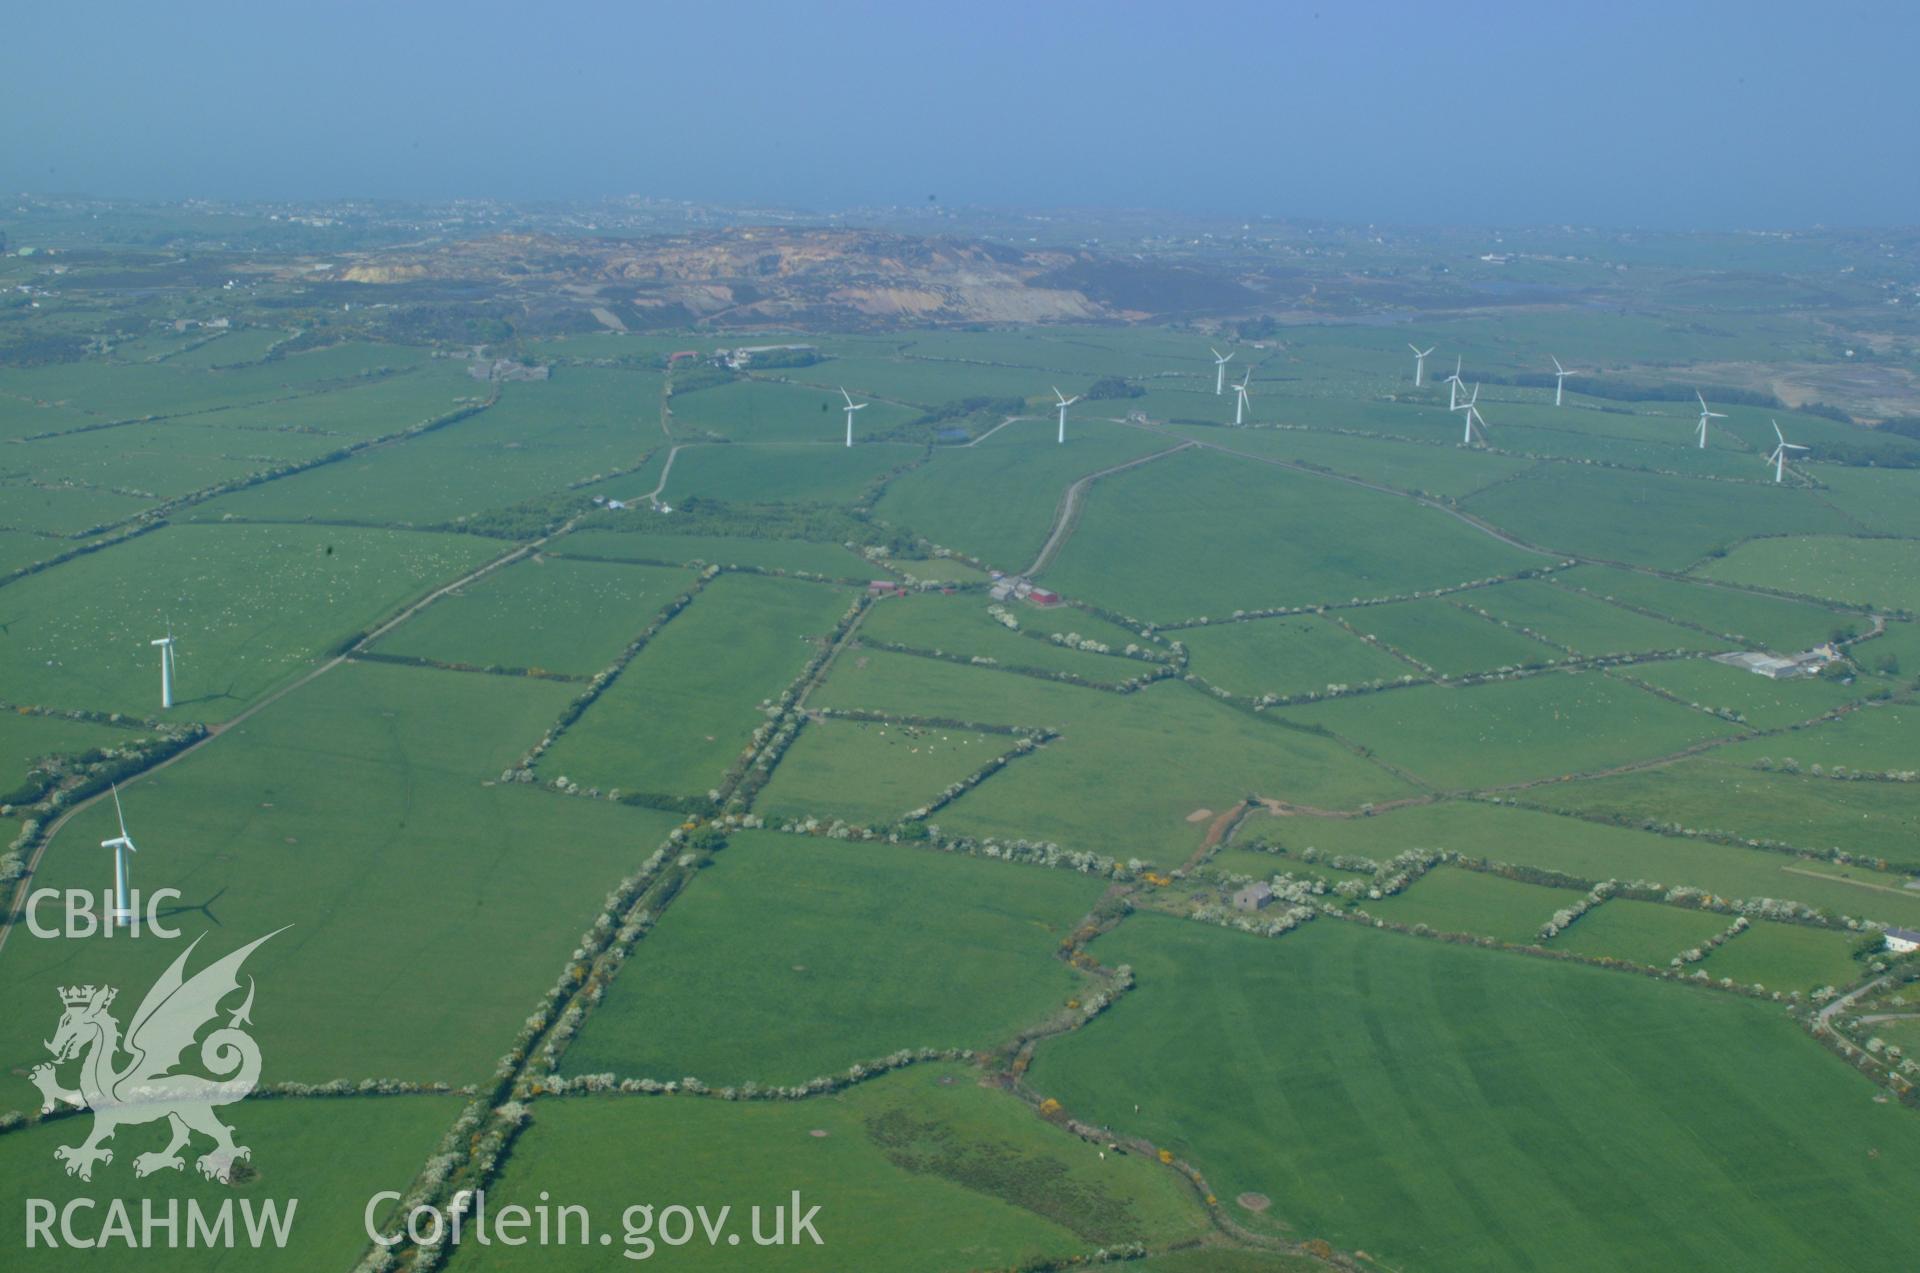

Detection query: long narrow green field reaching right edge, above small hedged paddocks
(1248, 806), (1920, 925)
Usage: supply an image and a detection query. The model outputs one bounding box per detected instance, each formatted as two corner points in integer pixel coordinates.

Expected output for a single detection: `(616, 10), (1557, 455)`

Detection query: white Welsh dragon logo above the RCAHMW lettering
(27, 929), (286, 1185)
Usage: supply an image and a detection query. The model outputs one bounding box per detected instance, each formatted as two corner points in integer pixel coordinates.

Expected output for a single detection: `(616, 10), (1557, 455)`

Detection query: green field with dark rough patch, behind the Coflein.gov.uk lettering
(449, 1066), (1206, 1273)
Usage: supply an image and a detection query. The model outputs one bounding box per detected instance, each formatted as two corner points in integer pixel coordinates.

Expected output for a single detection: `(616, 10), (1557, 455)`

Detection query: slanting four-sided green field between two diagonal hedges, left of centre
(528, 574), (852, 795)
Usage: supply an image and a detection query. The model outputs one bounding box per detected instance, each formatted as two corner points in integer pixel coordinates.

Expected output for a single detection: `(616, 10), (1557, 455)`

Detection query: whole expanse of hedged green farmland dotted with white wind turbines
(0, 196), (1920, 1273)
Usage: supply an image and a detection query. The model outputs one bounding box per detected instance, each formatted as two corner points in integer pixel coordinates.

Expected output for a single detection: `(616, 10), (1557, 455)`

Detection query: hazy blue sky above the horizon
(0, 0), (1920, 227)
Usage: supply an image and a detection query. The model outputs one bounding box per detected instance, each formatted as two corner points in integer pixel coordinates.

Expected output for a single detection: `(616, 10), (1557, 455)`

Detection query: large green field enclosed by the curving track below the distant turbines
(1046, 453), (1546, 622)
